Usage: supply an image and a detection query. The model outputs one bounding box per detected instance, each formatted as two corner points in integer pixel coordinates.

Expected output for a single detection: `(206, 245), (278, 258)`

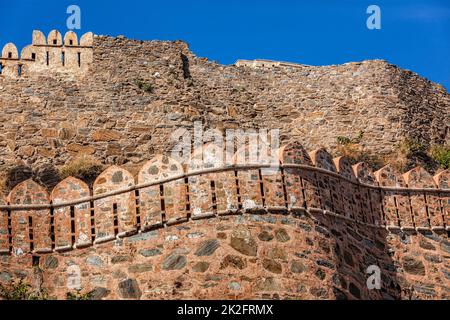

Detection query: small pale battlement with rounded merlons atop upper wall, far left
(0, 30), (94, 78)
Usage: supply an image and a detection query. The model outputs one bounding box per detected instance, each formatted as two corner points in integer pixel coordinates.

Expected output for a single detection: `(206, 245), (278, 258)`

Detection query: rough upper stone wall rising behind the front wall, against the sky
(0, 31), (450, 188)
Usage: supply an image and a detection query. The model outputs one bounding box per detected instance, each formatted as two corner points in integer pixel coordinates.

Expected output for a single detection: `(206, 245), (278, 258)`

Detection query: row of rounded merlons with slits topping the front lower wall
(0, 142), (450, 255)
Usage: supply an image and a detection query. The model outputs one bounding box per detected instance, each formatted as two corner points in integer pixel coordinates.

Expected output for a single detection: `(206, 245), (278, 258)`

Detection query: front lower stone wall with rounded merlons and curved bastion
(0, 142), (450, 299)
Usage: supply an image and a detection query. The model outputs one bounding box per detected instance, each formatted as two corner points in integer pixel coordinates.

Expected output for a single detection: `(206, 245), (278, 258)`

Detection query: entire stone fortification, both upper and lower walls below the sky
(0, 31), (450, 299)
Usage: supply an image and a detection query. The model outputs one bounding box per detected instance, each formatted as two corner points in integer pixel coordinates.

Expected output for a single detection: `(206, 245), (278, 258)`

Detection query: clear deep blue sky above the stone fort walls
(0, 0), (450, 90)
